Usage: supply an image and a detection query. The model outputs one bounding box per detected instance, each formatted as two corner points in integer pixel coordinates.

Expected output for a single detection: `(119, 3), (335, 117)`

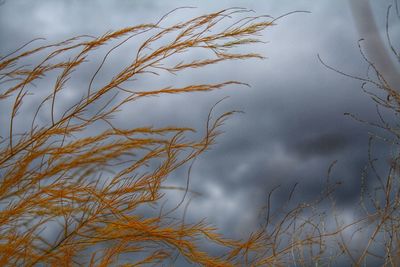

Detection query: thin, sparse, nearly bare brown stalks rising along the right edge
(321, 1), (400, 266)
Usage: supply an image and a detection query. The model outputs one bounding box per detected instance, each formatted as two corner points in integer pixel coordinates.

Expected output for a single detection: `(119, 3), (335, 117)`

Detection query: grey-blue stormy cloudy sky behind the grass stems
(0, 0), (400, 266)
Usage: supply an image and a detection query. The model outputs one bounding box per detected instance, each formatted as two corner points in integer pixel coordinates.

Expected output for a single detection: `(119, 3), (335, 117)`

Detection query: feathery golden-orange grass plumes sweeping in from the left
(0, 8), (273, 266)
